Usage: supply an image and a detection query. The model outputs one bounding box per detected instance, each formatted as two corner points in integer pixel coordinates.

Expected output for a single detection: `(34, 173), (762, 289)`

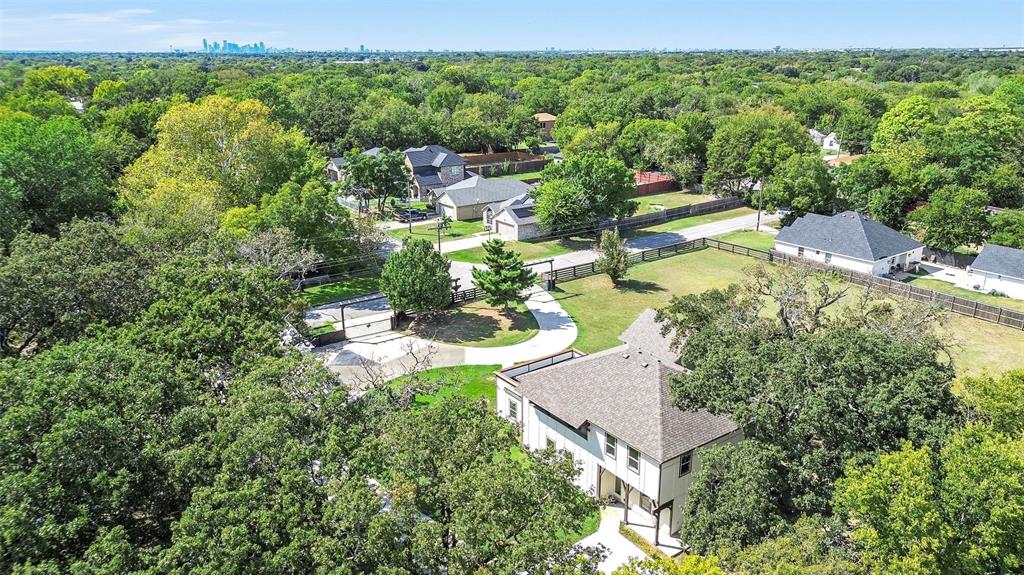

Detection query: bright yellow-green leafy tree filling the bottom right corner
(836, 426), (1024, 574)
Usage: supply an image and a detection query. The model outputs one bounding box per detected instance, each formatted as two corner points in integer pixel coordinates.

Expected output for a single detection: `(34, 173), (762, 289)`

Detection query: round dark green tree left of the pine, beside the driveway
(380, 238), (452, 313)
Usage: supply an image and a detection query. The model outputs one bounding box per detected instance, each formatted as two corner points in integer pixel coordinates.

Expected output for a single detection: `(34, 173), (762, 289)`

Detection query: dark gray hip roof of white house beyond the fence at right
(775, 211), (922, 262)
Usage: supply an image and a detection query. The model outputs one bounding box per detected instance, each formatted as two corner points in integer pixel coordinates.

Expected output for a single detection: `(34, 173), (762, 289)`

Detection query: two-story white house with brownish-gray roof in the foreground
(497, 309), (741, 544)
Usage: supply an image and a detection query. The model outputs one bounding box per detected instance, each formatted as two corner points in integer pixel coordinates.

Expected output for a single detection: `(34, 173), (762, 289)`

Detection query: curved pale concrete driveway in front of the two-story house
(314, 285), (578, 380)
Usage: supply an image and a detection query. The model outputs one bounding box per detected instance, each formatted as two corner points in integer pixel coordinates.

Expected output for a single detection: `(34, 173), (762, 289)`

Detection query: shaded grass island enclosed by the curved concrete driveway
(406, 301), (538, 348)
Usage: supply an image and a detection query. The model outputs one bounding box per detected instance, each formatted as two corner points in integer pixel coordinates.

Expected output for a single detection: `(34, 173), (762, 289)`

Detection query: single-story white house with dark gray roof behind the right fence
(775, 211), (925, 275)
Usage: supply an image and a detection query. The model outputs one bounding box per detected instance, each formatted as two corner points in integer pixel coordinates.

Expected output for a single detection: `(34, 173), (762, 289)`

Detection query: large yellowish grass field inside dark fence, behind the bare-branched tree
(554, 249), (1024, 373)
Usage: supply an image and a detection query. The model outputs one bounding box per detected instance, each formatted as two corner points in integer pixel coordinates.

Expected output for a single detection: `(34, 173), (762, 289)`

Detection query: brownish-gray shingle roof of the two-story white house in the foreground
(516, 310), (736, 462)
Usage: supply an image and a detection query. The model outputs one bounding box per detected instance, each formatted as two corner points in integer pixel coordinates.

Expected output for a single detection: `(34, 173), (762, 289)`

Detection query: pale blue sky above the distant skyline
(0, 0), (1024, 51)
